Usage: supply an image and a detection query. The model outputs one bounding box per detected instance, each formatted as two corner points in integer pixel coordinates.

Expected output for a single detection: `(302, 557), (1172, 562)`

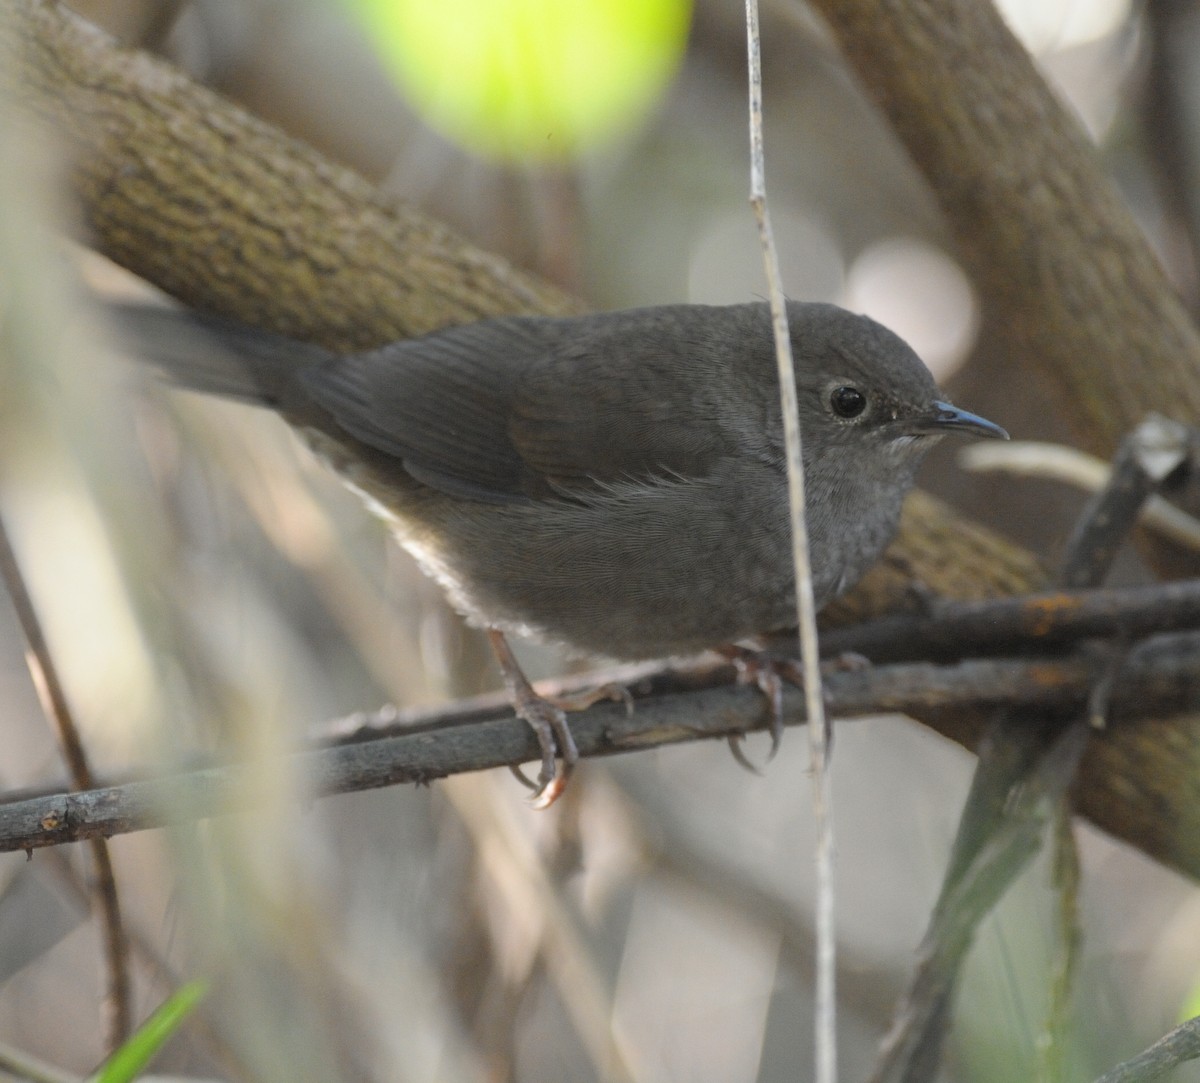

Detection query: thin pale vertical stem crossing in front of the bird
(746, 0), (838, 1083)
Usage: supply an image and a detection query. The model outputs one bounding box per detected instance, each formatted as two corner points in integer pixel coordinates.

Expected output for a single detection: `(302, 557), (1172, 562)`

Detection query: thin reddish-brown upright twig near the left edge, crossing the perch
(0, 517), (133, 1052)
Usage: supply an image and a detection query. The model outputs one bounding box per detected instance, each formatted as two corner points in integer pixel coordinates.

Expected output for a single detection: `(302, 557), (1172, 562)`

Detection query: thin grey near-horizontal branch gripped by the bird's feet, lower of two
(7, 634), (1200, 852)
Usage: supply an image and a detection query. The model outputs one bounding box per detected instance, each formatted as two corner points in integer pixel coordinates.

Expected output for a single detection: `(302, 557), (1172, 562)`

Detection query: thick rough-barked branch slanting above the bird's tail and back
(4, 0), (577, 348)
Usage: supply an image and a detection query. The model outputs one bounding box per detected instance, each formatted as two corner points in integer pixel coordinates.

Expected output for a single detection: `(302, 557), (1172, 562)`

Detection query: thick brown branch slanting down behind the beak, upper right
(801, 0), (1200, 456)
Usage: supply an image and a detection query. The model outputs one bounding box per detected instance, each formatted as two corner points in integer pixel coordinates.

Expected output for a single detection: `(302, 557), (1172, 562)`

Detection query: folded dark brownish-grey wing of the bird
(301, 317), (731, 502)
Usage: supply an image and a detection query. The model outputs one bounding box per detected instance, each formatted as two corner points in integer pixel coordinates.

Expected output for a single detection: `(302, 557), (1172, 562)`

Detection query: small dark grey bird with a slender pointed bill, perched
(118, 301), (1008, 807)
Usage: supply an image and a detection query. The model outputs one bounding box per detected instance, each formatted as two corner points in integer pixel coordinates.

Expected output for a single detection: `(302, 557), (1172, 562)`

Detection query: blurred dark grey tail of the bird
(112, 303), (332, 407)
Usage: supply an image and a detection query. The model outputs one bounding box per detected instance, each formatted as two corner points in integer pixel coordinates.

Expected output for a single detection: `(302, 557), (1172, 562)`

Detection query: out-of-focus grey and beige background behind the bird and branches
(0, 0), (1200, 1083)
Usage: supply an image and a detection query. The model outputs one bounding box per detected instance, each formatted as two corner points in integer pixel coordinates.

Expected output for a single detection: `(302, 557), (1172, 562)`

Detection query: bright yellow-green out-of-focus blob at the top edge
(348, 0), (690, 160)
